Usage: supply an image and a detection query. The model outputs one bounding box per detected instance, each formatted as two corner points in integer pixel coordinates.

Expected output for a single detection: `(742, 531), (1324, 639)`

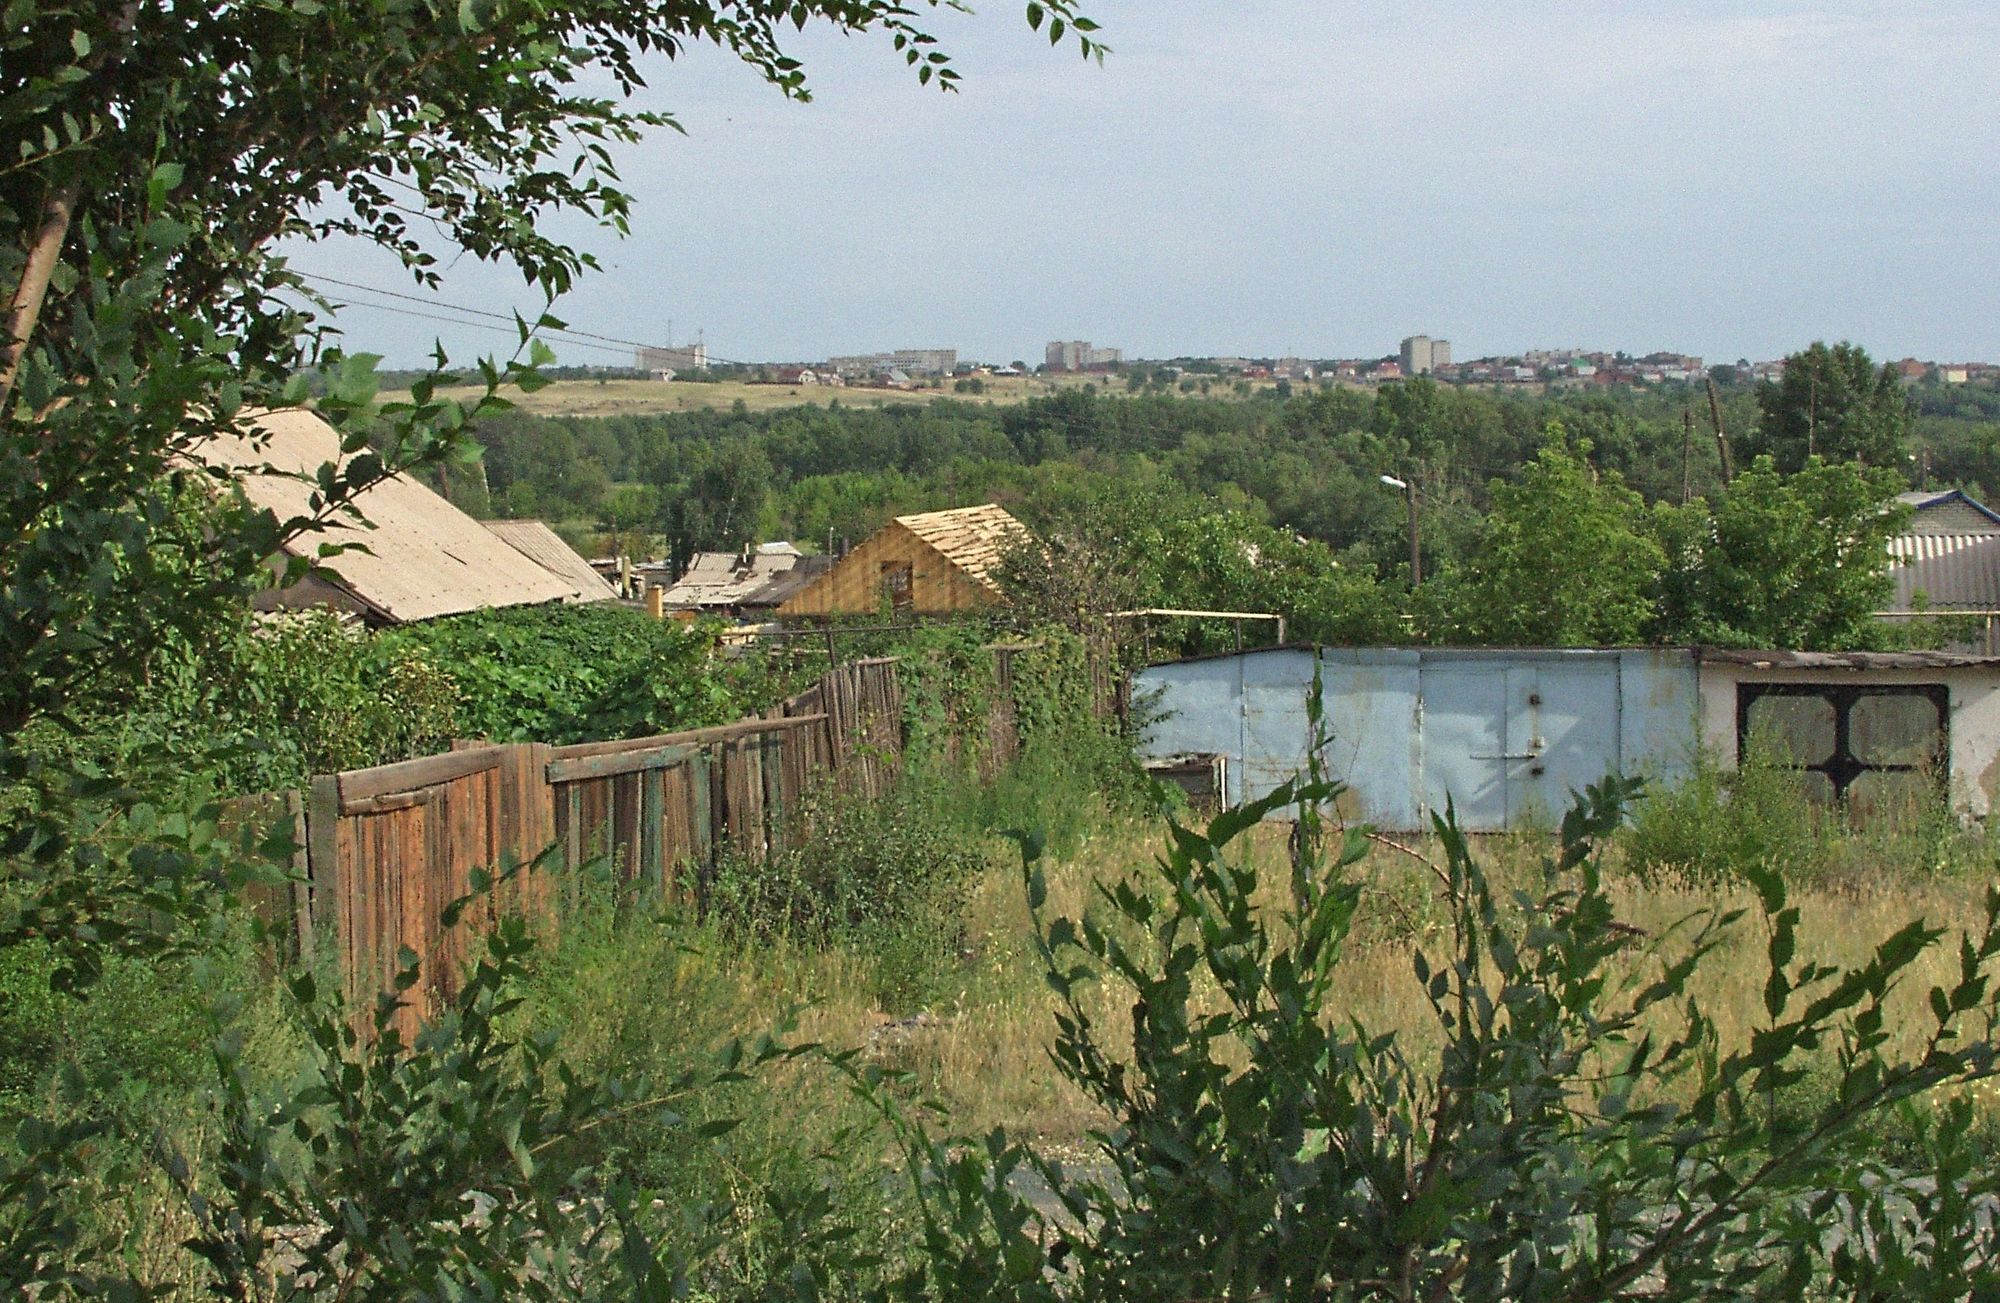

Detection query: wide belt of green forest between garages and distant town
(454, 344), (2000, 650)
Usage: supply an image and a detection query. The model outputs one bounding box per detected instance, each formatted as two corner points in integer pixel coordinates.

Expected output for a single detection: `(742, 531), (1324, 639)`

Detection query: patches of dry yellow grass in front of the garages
(696, 825), (1982, 1145)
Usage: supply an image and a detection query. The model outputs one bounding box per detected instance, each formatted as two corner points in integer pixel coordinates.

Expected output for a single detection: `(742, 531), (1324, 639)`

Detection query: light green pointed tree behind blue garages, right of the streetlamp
(1428, 424), (1666, 648)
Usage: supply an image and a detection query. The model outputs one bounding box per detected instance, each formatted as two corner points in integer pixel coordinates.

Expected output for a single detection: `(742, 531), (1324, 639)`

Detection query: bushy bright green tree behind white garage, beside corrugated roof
(1660, 456), (1910, 652)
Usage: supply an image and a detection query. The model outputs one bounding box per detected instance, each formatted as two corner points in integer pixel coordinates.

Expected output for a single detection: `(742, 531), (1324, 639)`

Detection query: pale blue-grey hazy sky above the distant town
(290, 0), (2000, 366)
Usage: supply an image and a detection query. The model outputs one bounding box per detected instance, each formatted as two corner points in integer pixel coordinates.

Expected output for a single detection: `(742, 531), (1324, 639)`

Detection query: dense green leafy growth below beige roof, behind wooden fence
(382, 602), (776, 743)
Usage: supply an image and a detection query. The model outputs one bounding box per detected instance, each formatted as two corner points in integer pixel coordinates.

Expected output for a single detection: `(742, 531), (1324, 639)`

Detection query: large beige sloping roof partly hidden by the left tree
(192, 410), (586, 622)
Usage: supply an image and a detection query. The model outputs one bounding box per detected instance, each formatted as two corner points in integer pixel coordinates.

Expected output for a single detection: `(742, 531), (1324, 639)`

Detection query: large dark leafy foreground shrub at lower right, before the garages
(884, 779), (2000, 1301)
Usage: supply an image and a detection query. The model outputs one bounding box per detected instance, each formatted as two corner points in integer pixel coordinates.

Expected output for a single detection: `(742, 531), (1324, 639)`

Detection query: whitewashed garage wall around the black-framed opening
(1700, 661), (2000, 819)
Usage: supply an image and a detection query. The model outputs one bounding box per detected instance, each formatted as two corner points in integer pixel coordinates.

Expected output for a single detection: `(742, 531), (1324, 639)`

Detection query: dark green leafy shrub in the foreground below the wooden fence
(166, 891), (884, 1299)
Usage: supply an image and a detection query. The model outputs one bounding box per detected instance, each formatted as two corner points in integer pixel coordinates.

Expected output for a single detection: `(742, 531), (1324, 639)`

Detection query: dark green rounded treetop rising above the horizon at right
(1742, 344), (1910, 474)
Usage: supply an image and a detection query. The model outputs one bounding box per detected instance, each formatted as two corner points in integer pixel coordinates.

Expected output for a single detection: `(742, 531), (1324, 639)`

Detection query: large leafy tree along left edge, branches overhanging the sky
(0, 0), (1098, 1297)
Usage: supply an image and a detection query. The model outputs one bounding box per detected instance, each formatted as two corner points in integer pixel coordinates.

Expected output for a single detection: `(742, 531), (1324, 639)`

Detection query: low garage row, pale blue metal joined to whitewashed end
(1134, 646), (2000, 831)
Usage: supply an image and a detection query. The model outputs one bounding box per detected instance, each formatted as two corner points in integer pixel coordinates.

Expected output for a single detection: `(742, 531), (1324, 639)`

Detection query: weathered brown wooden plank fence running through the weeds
(230, 659), (912, 1027)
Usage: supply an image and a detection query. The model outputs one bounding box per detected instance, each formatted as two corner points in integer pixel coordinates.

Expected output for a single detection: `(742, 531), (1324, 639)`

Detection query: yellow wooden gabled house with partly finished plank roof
(778, 502), (1030, 620)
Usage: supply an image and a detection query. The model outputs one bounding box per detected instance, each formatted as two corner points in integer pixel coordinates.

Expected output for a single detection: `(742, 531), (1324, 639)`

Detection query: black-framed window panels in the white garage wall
(1736, 683), (1950, 811)
